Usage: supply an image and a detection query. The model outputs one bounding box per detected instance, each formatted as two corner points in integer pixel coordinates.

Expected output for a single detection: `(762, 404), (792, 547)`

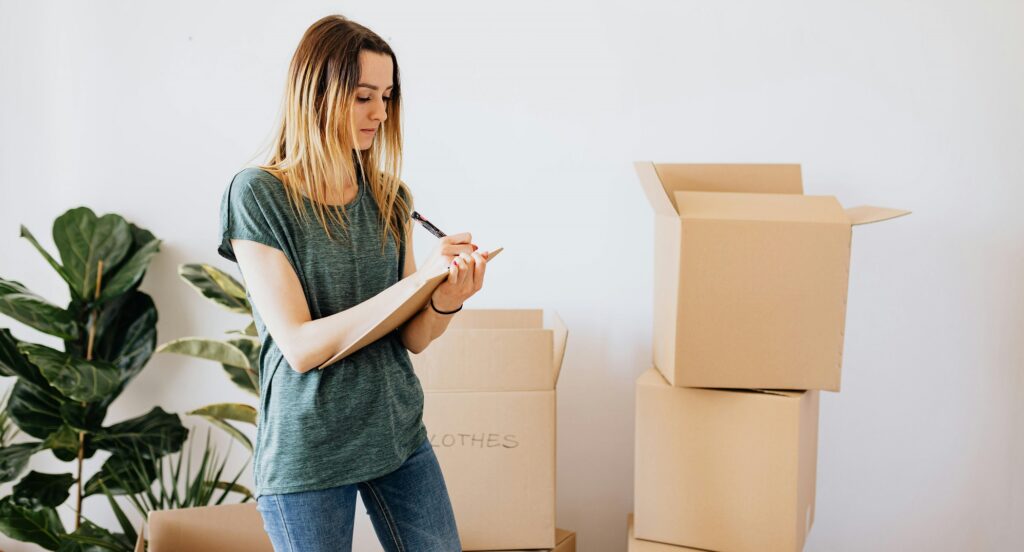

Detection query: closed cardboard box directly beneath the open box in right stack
(634, 368), (818, 552)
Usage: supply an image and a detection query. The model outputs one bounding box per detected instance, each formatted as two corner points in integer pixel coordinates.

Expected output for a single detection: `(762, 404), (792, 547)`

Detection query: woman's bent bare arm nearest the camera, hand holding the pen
(231, 233), (472, 373)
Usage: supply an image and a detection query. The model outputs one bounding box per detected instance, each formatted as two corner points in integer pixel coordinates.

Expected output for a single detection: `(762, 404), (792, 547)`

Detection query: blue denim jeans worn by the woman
(256, 439), (462, 552)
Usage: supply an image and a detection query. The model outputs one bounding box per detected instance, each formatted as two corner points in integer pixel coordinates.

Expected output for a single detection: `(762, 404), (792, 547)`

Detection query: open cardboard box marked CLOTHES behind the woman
(413, 310), (567, 550)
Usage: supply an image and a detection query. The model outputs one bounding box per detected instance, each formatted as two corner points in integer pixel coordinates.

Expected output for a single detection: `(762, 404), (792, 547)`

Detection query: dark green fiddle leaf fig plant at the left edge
(0, 207), (188, 551)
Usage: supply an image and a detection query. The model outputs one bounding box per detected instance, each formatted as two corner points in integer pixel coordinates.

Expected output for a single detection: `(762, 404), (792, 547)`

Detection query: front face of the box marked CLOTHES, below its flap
(423, 390), (555, 550)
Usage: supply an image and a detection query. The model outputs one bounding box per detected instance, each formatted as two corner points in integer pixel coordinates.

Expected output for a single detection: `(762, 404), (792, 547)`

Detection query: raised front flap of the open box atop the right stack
(675, 192), (849, 224)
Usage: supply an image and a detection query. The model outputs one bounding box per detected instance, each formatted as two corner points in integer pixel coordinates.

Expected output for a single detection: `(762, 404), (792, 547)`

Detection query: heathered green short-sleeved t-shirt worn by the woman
(217, 168), (427, 497)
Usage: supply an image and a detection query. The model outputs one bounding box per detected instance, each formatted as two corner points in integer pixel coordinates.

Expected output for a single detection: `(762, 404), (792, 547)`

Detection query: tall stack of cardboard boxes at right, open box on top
(630, 162), (907, 552)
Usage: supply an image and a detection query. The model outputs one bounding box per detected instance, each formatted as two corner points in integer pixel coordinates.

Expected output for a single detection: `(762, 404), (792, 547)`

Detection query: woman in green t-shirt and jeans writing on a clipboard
(218, 15), (486, 552)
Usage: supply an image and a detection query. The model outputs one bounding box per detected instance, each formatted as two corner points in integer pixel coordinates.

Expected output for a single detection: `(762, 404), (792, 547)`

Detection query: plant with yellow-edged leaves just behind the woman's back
(157, 263), (261, 453)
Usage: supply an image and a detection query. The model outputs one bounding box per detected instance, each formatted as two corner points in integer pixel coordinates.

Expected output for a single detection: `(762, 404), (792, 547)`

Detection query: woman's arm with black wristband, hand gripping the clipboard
(400, 224), (487, 353)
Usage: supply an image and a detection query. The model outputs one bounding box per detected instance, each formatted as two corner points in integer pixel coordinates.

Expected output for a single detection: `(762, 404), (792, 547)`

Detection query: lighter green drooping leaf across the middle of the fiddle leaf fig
(17, 342), (121, 402)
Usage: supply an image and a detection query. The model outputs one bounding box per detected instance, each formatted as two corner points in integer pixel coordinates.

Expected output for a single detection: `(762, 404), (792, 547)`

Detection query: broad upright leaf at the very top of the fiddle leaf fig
(53, 207), (132, 299)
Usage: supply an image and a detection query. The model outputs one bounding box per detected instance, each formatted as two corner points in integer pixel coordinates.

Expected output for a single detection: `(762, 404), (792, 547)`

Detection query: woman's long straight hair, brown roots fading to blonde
(259, 15), (412, 246)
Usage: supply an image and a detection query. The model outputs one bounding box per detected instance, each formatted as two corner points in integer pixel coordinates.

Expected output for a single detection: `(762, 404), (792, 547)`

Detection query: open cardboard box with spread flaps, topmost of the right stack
(635, 162), (908, 391)
